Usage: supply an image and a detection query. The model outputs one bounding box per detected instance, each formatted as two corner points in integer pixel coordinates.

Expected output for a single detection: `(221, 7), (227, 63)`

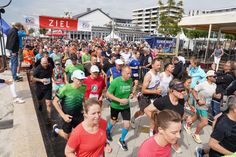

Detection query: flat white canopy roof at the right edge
(178, 11), (236, 34)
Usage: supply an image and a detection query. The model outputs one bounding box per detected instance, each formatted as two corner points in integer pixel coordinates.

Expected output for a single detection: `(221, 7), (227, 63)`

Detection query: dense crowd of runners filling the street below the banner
(2, 23), (236, 157)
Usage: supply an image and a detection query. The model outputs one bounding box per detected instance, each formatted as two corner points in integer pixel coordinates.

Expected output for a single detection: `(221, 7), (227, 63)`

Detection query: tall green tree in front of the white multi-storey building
(158, 0), (184, 37)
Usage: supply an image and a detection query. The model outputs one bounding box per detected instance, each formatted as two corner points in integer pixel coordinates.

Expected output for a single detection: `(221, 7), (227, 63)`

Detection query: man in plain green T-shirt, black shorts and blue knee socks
(106, 66), (133, 151)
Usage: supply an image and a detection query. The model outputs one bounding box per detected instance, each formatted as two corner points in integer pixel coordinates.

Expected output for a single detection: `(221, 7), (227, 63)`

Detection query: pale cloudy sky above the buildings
(0, 0), (236, 23)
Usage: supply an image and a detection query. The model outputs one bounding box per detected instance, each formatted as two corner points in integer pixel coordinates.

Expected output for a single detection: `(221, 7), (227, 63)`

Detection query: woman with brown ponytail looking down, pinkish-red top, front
(138, 110), (182, 157)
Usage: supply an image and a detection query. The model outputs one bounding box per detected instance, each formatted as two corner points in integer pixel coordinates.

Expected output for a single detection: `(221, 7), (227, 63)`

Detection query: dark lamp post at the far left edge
(0, 0), (12, 69)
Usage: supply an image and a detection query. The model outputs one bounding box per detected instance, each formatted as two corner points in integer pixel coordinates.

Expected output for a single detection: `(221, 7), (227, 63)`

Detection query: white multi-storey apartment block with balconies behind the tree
(132, 5), (183, 34)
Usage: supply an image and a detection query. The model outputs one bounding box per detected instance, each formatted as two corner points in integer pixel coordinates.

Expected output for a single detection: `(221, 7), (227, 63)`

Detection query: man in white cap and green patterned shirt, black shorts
(53, 70), (86, 140)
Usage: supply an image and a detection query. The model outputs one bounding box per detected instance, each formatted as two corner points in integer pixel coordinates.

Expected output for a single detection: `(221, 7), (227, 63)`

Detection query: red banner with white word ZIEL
(39, 16), (78, 31)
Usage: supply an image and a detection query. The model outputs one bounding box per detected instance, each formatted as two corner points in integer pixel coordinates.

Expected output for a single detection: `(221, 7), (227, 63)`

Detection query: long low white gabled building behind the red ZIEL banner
(71, 8), (147, 41)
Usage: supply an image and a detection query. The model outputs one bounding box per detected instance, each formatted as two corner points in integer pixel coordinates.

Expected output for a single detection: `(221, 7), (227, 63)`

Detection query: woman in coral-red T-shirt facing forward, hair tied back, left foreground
(65, 99), (112, 157)
